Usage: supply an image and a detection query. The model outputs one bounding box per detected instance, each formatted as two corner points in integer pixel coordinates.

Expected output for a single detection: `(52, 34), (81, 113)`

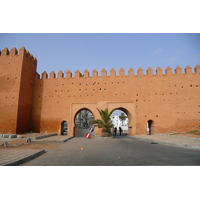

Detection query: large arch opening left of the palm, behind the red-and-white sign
(74, 109), (94, 137)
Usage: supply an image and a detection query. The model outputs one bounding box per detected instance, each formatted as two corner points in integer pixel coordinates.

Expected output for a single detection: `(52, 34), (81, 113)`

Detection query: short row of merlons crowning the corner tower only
(0, 47), (37, 64)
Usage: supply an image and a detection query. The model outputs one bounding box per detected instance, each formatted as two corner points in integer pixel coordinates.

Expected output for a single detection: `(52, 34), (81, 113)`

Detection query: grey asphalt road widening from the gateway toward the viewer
(22, 137), (200, 166)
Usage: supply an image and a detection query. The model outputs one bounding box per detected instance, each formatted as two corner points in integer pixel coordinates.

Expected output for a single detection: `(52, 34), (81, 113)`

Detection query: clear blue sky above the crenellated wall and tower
(0, 33), (200, 76)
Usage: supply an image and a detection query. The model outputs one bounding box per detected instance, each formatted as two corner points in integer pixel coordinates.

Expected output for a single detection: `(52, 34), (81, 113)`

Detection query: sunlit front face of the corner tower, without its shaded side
(0, 48), (23, 133)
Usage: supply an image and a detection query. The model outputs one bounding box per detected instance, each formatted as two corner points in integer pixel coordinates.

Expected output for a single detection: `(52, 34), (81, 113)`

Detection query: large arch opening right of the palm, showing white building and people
(111, 108), (129, 136)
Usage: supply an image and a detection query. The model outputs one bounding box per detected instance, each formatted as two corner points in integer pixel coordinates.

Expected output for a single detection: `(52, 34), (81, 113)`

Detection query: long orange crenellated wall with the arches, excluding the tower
(33, 65), (200, 135)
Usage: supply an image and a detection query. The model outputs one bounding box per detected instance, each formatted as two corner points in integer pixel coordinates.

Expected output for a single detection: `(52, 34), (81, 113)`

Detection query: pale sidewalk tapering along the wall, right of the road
(128, 134), (200, 150)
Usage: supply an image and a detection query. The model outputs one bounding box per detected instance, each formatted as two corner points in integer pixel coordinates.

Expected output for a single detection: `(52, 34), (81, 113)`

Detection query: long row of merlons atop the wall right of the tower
(38, 65), (200, 79)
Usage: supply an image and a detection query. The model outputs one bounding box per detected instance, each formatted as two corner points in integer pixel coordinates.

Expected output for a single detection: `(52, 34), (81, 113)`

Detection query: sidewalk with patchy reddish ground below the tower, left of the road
(0, 134), (73, 166)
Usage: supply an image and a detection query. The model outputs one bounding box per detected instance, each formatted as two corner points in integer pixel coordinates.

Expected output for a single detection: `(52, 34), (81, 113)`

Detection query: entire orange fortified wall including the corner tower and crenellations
(0, 48), (200, 135)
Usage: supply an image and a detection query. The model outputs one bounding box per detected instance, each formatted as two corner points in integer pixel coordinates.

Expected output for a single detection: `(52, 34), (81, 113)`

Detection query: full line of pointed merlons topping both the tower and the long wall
(0, 47), (200, 79)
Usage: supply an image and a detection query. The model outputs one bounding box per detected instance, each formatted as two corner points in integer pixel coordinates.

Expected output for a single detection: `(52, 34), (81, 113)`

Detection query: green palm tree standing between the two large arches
(89, 108), (113, 137)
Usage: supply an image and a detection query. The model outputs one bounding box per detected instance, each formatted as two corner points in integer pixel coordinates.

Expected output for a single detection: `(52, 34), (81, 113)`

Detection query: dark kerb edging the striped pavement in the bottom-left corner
(2, 149), (46, 166)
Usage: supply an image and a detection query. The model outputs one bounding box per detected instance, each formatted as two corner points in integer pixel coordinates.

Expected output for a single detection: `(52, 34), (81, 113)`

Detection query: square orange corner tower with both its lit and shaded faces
(0, 48), (36, 133)
